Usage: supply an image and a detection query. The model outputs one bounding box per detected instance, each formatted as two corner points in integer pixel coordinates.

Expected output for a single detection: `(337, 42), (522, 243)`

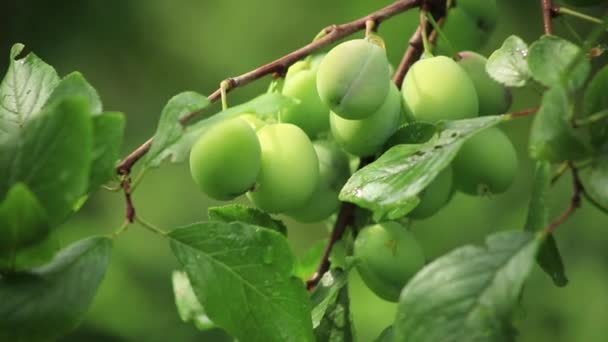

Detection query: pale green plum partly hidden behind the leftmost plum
(246, 123), (319, 213)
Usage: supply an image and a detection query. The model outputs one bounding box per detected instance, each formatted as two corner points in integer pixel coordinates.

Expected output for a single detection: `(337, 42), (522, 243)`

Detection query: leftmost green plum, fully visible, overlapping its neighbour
(190, 118), (261, 200)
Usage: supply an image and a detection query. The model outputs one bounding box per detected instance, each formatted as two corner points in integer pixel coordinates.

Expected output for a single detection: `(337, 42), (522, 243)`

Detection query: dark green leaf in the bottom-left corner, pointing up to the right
(0, 237), (112, 341)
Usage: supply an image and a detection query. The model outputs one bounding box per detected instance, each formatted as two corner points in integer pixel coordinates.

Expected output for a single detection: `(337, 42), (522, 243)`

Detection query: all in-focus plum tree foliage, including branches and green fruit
(0, 0), (608, 342)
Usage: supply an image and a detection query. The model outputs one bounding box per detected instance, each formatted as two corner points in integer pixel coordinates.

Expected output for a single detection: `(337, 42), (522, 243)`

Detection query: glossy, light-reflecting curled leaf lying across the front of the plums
(340, 116), (504, 220)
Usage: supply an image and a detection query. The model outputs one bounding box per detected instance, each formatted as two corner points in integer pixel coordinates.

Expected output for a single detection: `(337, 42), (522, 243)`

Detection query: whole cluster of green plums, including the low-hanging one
(190, 27), (517, 301)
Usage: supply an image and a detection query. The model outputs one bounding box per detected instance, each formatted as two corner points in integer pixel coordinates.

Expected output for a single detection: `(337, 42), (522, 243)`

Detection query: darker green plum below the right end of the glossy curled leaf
(452, 127), (517, 195)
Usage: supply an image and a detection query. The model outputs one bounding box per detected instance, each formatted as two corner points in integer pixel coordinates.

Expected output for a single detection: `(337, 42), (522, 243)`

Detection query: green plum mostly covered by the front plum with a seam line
(329, 83), (403, 157)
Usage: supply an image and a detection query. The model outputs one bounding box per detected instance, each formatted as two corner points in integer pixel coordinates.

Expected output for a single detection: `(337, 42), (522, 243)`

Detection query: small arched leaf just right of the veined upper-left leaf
(45, 71), (103, 114)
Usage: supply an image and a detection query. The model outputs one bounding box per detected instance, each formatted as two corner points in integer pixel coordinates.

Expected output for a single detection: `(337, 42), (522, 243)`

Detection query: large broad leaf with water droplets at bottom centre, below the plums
(169, 222), (313, 342)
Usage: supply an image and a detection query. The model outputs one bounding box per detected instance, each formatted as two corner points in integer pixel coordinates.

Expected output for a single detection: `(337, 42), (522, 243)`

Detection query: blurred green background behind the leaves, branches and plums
(0, 0), (608, 342)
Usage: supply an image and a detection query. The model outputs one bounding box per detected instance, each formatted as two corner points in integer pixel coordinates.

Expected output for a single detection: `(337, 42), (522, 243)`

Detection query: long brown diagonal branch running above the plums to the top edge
(116, 0), (423, 175)
